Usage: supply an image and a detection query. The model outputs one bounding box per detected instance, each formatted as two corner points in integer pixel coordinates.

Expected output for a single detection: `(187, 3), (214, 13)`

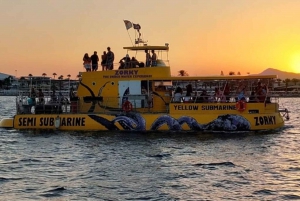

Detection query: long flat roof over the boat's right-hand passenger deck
(150, 75), (277, 81)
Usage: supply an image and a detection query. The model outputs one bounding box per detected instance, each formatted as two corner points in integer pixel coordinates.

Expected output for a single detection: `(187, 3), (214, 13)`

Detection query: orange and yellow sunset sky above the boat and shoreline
(0, 0), (300, 78)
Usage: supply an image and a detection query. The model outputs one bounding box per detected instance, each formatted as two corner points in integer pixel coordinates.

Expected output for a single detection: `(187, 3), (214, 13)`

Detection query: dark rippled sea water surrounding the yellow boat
(0, 97), (300, 201)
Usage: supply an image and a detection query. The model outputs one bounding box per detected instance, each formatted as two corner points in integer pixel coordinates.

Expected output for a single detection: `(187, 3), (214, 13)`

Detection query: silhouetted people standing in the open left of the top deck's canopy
(82, 47), (115, 72)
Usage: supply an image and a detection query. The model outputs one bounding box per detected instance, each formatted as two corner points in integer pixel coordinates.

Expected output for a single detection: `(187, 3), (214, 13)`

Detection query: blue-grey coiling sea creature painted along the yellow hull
(88, 112), (251, 131)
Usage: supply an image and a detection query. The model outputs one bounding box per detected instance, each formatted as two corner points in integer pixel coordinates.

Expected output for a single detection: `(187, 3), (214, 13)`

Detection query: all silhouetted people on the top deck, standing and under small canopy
(82, 47), (157, 72)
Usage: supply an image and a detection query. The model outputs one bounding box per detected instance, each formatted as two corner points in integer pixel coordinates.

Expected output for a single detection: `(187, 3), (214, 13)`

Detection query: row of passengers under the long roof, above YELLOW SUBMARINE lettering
(173, 82), (270, 103)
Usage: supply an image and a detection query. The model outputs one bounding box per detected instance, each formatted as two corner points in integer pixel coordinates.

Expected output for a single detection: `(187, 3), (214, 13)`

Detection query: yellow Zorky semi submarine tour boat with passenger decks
(0, 44), (288, 131)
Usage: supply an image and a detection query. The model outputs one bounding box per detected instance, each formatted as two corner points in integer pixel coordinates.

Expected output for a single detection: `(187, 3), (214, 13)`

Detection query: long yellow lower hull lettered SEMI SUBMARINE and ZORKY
(0, 112), (284, 131)
